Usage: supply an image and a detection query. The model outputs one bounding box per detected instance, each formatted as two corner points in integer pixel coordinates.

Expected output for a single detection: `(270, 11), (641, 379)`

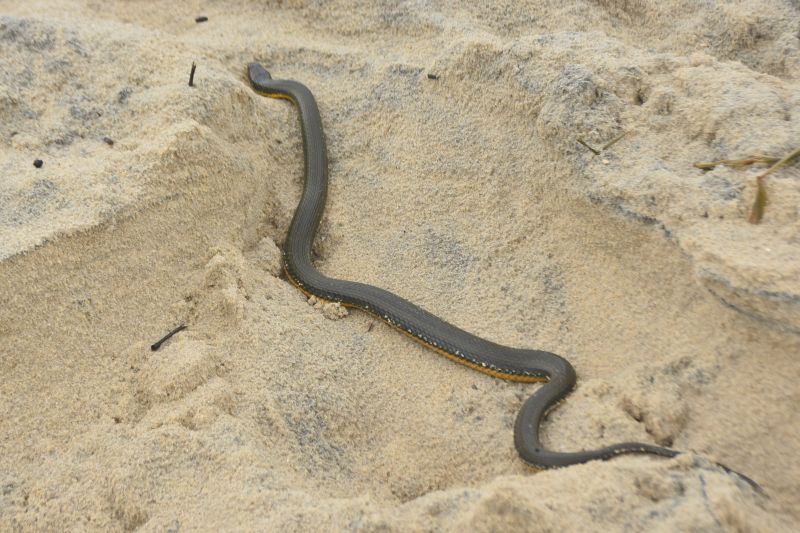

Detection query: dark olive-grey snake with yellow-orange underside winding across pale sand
(247, 63), (757, 486)
